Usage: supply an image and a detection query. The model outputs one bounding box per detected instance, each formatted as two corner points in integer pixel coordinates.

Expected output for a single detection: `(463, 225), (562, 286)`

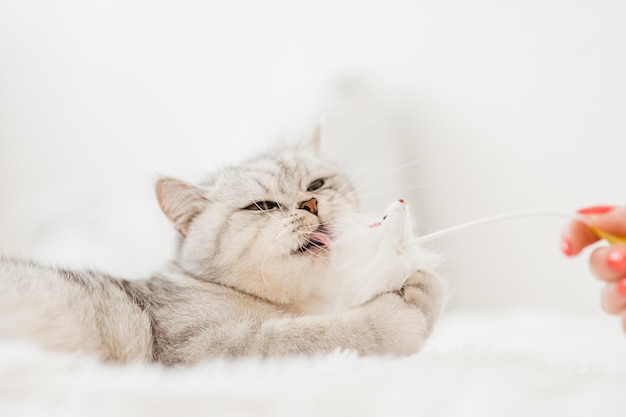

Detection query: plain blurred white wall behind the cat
(0, 0), (626, 313)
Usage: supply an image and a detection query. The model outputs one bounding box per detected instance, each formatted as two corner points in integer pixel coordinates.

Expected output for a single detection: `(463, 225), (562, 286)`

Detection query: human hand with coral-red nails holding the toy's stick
(561, 206), (626, 332)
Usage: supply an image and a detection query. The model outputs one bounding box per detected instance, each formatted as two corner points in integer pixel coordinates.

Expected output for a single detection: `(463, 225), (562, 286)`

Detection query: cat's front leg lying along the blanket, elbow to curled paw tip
(256, 270), (446, 355)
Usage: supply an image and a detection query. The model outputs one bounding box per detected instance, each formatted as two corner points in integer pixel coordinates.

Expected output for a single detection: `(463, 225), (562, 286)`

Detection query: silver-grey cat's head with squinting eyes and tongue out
(156, 138), (357, 303)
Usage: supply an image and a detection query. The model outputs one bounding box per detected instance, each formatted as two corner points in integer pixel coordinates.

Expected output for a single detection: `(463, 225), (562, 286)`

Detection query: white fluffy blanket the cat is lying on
(0, 311), (626, 417)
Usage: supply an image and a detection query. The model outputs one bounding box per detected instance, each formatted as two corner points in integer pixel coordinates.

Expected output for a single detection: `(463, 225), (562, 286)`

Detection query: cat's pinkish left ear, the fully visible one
(155, 178), (207, 236)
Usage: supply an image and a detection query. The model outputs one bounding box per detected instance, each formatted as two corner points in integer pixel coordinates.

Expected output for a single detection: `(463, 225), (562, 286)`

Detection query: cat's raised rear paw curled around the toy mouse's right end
(397, 270), (446, 333)
